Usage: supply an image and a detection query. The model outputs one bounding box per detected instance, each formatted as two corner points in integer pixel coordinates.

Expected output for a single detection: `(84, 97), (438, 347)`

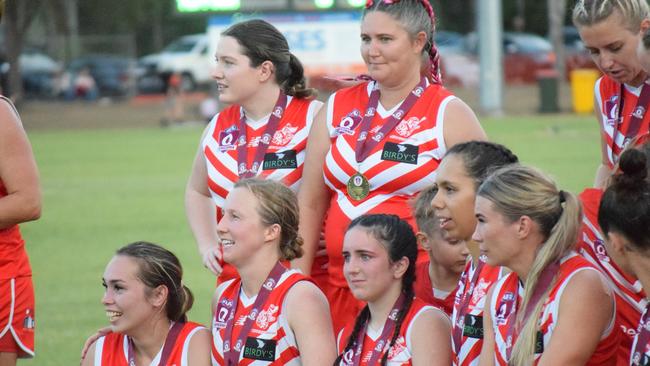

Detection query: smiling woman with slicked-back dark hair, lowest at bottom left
(81, 242), (210, 366)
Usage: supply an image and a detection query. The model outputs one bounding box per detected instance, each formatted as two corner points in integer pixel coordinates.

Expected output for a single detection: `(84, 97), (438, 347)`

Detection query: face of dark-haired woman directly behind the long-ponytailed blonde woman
(431, 154), (476, 240)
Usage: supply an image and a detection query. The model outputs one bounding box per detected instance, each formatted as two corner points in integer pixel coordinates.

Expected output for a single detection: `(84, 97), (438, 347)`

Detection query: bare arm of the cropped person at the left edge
(0, 101), (41, 230)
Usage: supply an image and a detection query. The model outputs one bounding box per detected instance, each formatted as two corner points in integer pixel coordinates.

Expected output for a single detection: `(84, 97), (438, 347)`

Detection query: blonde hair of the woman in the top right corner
(573, 0), (650, 32)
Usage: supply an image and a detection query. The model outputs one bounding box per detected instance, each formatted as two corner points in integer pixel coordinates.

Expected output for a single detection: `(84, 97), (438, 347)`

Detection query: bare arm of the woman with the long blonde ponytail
(539, 270), (616, 366)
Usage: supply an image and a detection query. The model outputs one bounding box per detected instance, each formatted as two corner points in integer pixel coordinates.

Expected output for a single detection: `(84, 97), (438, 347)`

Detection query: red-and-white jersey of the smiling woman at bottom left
(94, 322), (205, 366)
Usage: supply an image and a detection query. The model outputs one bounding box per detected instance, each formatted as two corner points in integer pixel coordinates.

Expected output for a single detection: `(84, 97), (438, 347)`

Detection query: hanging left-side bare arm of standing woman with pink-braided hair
(291, 108), (330, 274)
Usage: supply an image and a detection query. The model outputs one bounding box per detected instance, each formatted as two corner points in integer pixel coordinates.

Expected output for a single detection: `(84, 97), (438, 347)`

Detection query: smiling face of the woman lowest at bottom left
(102, 255), (164, 335)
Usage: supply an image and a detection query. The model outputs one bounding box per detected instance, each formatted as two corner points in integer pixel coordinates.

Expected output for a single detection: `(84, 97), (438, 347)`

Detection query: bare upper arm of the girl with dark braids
(411, 309), (451, 366)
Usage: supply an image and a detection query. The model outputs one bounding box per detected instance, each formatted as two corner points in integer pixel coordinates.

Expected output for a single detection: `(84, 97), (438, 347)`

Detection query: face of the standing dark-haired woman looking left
(212, 36), (261, 104)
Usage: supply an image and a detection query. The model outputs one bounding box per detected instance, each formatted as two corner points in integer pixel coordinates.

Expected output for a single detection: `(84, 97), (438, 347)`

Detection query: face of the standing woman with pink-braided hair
(361, 11), (426, 85)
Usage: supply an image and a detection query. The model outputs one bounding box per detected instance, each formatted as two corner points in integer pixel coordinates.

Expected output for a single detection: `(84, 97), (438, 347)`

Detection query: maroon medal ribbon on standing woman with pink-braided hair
(354, 77), (427, 163)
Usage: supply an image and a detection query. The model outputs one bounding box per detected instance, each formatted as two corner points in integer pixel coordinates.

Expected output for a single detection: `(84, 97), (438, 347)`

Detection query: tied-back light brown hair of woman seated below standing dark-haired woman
(235, 178), (303, 260)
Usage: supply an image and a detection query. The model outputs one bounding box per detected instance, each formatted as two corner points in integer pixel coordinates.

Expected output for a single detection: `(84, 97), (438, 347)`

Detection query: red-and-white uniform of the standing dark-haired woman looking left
(201, 96), (326, 284)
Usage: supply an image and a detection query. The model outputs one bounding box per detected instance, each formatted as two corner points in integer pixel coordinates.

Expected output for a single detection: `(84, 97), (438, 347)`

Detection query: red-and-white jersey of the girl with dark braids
(336, 297), (441, 366)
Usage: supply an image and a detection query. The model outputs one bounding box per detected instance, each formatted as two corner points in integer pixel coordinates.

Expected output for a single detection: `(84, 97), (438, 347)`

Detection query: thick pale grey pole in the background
(476, 0), (503, 116)
